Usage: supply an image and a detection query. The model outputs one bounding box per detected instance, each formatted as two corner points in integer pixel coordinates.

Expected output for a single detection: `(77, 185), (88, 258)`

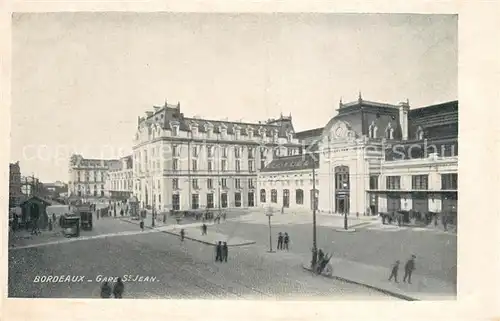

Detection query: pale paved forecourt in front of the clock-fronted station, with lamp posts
(214, 213), (457, 284)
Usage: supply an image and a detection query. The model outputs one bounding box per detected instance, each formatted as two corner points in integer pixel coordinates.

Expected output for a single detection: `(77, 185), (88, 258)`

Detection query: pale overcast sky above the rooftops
(11, 13), (458, 182)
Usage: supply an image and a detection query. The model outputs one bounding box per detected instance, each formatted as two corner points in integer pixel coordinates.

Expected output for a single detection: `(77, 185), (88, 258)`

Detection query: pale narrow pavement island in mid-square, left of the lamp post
(120, 217), (255, 246)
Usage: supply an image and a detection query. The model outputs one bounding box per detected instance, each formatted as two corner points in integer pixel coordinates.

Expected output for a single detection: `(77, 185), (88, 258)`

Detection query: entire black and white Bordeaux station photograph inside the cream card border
(5, 12), (460, 302)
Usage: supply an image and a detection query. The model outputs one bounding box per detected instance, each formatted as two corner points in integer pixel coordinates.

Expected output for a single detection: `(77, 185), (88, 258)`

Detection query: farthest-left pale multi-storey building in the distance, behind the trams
(68, 155), (119, 198)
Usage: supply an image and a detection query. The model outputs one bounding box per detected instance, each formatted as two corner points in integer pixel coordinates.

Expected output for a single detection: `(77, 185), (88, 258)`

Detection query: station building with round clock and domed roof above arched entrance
(258, 95), (458, 215)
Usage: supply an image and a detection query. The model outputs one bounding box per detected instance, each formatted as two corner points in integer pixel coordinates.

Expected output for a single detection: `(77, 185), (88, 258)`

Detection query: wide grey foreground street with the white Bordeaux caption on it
(8, 211), (394, 300)
